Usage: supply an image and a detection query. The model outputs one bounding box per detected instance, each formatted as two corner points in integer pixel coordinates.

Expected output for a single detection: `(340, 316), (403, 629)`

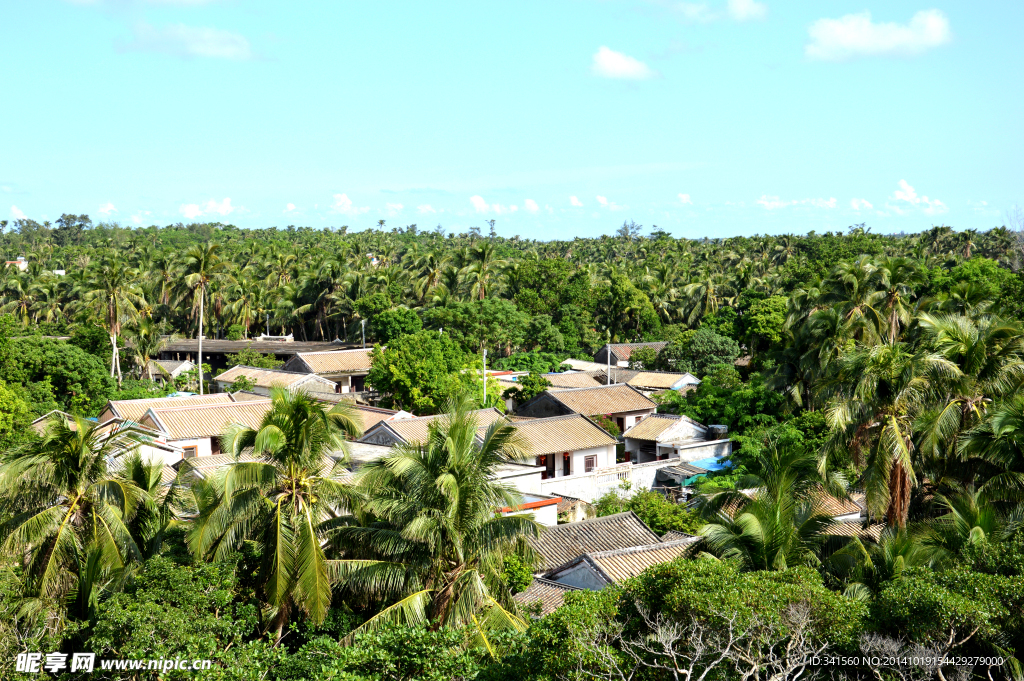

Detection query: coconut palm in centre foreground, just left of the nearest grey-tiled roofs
(337, 394), (540, 644)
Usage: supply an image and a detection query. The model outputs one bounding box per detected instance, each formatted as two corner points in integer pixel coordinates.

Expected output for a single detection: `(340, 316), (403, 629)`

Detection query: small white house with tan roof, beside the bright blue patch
(623, 414), (732, 464)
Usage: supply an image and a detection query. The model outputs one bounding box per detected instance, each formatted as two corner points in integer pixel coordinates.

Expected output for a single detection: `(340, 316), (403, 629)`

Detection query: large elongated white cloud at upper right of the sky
(804, 9), (952, 61)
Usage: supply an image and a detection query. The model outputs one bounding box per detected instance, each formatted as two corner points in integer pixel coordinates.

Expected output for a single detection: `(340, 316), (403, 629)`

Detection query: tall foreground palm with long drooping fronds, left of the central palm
(187, 388), (359, 642)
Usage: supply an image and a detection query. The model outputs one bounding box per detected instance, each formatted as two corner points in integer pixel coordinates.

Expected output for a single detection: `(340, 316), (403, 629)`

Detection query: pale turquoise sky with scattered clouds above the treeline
(0, 0), (1024, 240)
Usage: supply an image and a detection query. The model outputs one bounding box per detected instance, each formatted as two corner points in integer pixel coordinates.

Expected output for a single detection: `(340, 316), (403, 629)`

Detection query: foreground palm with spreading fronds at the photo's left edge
(0, 417), (146, 598)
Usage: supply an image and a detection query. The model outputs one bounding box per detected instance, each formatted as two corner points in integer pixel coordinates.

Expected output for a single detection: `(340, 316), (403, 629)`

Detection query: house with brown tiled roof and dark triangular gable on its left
(516, 384), (657, 431)
